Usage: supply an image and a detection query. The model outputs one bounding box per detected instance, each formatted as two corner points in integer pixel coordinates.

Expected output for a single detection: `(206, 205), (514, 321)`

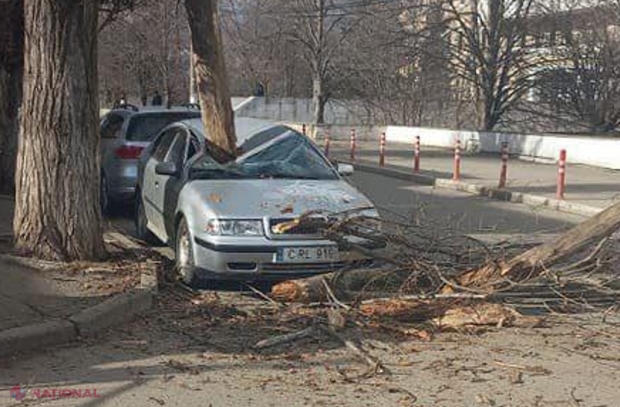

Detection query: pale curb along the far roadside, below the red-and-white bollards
(338, 159), (604, 217)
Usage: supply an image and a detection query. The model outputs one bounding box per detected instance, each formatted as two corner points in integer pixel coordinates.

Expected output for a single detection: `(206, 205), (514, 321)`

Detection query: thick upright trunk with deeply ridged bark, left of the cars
(14, 0), (104, 260)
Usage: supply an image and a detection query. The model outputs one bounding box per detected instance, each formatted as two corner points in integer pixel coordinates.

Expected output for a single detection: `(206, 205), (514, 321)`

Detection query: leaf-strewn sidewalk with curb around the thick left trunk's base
(0, 196), (152, 357)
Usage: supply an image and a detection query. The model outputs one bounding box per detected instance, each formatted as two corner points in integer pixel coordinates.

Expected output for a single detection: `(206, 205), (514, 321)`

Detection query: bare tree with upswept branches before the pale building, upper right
(431, 0), (541, 130)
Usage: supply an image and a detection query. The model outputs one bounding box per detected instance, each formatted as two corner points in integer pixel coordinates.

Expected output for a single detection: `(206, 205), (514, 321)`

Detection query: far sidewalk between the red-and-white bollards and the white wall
(332, 140), (620, 209)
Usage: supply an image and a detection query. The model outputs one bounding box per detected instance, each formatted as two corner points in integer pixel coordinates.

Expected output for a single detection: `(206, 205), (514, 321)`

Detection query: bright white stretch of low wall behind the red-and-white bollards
(386, 126), (620, 171)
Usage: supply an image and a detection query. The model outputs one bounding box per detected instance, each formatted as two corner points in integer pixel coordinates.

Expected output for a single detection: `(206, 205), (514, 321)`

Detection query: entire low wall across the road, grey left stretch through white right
(233, 97), (620, 169)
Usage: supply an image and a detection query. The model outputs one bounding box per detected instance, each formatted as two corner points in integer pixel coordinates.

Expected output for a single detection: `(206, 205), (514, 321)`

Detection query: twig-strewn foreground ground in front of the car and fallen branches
(0, 289), (620, 407)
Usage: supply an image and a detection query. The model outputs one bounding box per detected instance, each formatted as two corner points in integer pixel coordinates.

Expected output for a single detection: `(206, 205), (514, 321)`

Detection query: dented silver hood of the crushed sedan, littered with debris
(184, 179), (374, 218)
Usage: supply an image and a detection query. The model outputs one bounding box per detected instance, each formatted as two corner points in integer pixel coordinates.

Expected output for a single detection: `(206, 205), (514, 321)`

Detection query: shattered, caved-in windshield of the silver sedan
(192, 130), (338, 180)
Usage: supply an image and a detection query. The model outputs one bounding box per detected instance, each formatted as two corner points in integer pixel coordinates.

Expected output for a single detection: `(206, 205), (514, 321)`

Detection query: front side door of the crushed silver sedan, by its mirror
(153, 128), (187, 242)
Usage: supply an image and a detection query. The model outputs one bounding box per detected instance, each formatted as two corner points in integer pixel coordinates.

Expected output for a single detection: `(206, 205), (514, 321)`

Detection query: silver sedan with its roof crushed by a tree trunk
(136, 119), (378, 284)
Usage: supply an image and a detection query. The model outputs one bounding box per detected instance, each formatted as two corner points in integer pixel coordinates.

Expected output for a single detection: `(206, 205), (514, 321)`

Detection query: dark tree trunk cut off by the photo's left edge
(0, 0), (24, 192)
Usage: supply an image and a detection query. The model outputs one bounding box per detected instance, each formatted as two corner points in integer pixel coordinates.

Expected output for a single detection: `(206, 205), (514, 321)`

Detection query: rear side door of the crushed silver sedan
(141, 127), (179, 241)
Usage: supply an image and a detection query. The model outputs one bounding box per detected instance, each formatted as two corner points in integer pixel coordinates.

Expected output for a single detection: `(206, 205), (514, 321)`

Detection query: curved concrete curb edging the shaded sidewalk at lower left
(0, 237), (157, 357)
